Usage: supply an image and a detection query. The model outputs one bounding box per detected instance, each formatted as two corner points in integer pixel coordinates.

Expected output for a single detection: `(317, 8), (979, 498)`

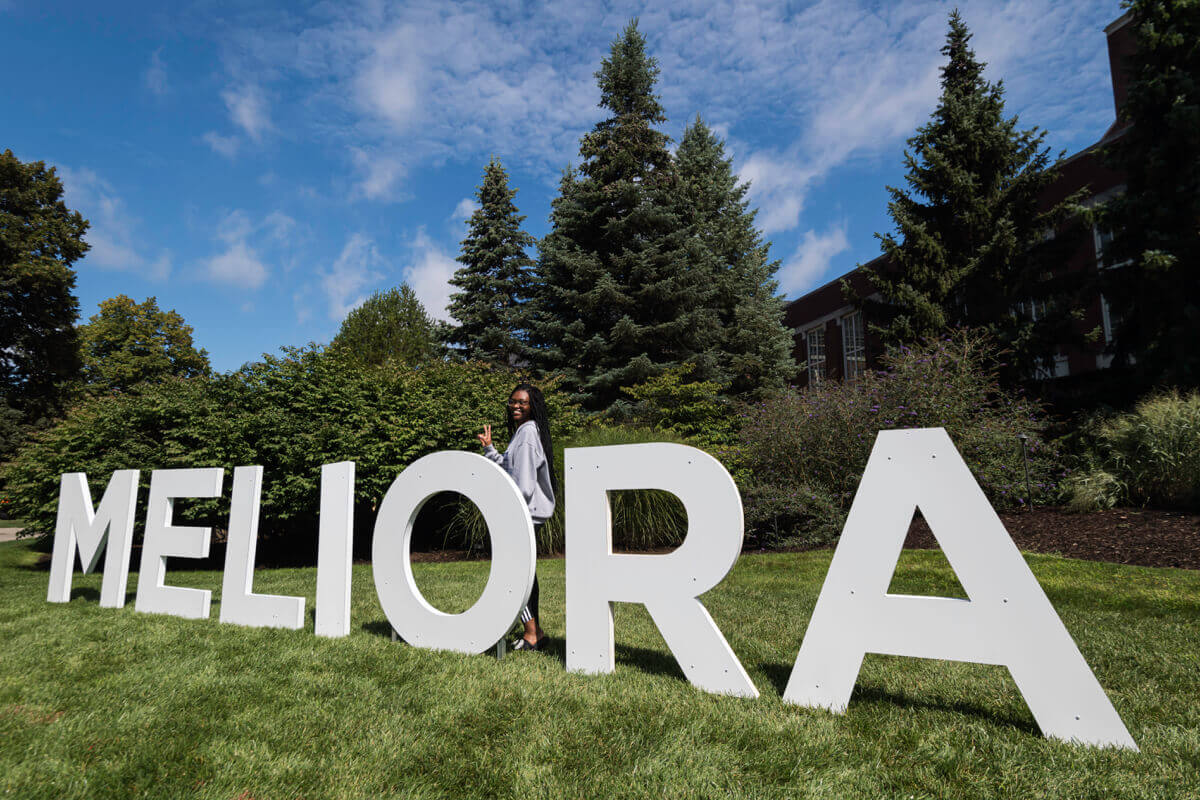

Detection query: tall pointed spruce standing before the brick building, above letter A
(864, 11), (1074, 380)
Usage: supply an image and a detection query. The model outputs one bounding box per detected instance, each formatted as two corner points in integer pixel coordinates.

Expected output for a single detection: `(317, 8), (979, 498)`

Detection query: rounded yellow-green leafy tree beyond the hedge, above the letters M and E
(79, 295), (209, 391)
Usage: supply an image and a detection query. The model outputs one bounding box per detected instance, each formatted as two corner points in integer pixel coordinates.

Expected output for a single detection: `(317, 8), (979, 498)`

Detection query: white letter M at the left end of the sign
(46, 469), (138, 608)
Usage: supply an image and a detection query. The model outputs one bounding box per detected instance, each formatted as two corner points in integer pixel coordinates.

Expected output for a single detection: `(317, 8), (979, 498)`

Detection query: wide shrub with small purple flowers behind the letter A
(739, 332), (1061, 543)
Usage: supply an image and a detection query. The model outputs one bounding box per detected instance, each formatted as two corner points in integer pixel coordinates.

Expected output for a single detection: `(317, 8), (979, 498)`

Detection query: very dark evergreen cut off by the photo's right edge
(1100, 0), (1200, 387)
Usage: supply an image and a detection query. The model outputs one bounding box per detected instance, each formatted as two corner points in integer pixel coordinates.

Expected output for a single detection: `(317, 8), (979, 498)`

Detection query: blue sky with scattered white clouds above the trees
(0, 0), (1121, 371)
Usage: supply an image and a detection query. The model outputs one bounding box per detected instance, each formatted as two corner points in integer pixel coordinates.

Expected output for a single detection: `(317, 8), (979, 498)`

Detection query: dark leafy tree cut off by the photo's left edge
(0, 150), (88, 422)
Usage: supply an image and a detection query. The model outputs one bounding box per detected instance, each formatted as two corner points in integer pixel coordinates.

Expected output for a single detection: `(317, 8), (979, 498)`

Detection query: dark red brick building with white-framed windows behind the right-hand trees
(784, 13), (1134, 385)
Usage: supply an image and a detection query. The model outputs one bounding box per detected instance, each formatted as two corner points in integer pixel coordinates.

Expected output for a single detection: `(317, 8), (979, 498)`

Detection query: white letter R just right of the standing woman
(565, 444), (758, 697)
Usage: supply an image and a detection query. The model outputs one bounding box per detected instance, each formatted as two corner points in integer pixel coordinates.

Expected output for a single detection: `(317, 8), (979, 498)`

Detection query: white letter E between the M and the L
(134, 467), (224, 619)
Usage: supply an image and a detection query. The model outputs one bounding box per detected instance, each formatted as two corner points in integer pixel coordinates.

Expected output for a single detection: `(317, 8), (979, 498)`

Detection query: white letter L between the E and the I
(219, 467), (304, 628)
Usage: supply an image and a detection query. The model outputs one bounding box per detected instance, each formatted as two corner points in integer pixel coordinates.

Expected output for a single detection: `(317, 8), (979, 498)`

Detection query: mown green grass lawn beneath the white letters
(0, 542), (1200, 800)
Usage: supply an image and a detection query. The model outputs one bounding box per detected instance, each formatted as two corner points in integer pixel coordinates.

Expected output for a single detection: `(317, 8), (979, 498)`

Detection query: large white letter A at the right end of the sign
(784, 428), (1138, 750)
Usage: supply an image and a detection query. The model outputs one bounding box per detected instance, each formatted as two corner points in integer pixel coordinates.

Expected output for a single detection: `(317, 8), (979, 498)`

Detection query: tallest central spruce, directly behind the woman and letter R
(530, 20), (719, 409)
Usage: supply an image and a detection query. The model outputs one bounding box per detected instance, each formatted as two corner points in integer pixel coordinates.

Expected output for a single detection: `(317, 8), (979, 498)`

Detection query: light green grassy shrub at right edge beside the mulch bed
(1066, 392), (1200, 511)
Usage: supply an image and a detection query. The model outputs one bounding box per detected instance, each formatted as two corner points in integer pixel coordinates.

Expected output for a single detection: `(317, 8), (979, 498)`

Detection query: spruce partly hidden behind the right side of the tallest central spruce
(673, 115), (796, 396)
